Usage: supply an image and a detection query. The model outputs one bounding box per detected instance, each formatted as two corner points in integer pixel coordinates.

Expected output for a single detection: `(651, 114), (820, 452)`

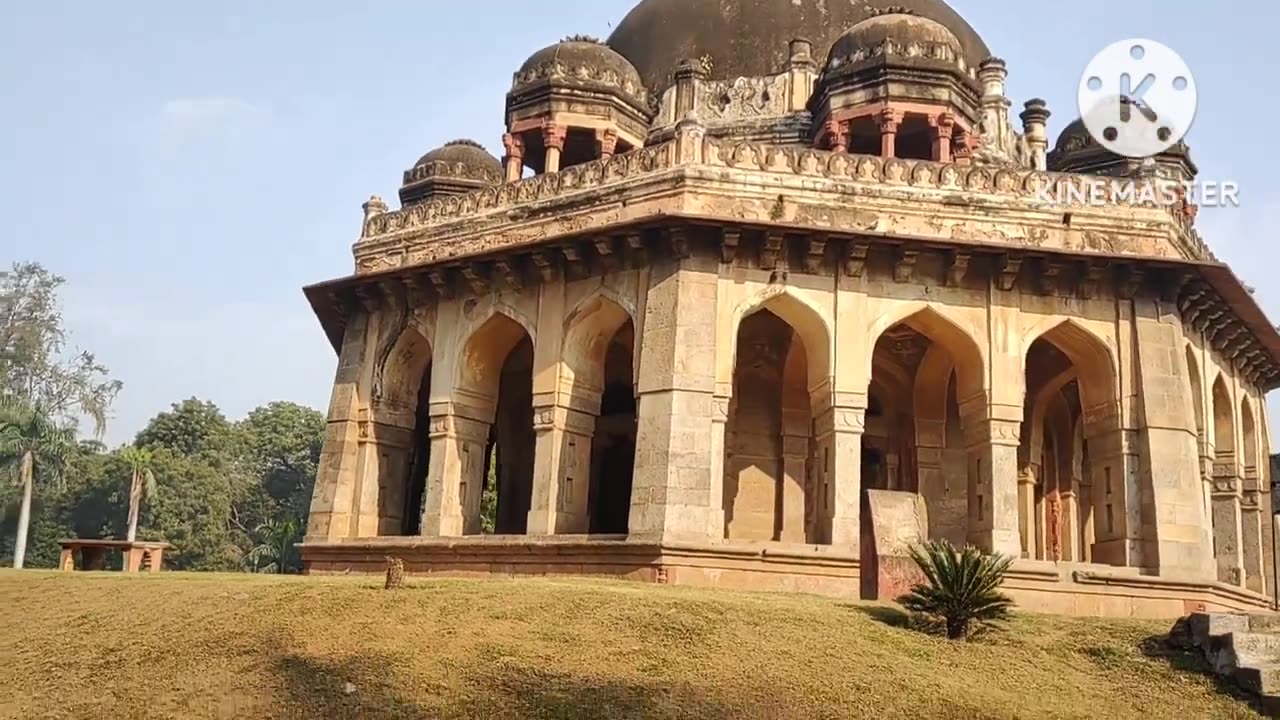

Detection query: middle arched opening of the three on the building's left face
(454, 314), (535, 536)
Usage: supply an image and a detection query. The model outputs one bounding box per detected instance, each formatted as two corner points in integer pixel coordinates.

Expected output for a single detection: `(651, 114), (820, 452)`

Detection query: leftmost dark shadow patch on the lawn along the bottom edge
(273, 653), (434, 720)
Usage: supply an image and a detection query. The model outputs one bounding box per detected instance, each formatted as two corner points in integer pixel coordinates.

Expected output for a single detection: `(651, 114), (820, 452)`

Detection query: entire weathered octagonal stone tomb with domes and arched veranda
(302, 0), (1280, 616)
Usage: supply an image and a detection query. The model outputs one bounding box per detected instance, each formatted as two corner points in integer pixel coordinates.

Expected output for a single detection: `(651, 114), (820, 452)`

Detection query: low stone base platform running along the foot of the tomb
(301, 536), (1271, 619)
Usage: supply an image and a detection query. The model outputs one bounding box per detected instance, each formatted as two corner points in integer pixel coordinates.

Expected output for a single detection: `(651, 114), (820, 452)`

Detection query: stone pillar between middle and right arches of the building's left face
(529, 398), (599, 536)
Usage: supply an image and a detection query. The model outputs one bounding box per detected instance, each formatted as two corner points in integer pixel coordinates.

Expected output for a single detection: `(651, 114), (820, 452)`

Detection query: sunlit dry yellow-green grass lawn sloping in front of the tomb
(0, 570), (1257, 720)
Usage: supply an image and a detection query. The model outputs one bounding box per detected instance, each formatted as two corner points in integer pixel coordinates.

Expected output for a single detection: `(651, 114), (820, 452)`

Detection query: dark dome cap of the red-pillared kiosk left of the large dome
(512, 36), (649, 108)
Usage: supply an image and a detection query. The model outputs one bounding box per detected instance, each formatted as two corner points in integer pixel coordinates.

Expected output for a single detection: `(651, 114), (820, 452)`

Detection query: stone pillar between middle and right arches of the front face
(965, 413), (1023, 557)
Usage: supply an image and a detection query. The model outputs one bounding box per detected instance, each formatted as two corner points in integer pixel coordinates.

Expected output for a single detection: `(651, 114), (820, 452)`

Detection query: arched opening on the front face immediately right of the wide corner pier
(722, 295), (829, 543)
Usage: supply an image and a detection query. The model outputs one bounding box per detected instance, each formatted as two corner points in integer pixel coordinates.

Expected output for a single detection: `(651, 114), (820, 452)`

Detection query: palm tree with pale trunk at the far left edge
(0, 396), (76, 569)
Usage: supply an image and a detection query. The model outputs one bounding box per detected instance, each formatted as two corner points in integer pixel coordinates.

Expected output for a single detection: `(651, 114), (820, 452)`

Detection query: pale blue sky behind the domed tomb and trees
(0, 0), (1280, 445)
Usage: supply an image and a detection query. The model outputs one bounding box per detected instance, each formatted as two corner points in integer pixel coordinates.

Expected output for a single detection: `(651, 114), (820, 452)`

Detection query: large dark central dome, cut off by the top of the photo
(609, 0), (991, 91)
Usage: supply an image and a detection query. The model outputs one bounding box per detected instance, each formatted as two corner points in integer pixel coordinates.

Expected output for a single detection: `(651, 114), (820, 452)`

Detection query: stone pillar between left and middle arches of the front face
(814, 395), (867, 543)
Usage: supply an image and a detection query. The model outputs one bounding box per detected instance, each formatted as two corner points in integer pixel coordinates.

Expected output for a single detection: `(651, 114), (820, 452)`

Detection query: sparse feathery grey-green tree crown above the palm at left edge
(0, 263), (122, 436)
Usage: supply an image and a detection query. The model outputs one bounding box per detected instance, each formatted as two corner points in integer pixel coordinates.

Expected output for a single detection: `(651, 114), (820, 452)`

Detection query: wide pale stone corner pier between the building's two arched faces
(630, 252), (719, 542)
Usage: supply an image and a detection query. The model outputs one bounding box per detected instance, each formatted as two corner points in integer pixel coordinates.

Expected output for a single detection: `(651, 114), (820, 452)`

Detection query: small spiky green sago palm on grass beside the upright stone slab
(899, 541), (1014, 639)
